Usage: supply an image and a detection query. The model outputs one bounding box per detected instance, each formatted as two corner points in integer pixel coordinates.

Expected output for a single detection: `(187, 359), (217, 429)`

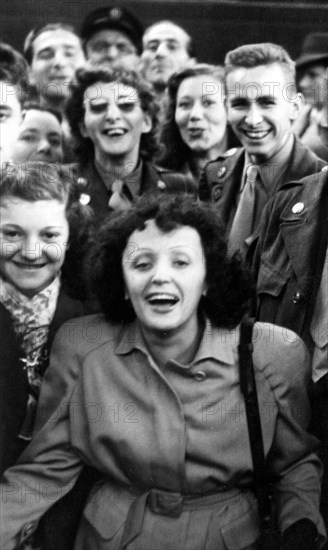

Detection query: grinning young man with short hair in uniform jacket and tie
(199, 43), (325, 256)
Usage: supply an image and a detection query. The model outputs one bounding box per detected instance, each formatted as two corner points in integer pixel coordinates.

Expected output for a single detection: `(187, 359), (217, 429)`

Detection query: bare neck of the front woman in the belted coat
(141, 321), (204, 369)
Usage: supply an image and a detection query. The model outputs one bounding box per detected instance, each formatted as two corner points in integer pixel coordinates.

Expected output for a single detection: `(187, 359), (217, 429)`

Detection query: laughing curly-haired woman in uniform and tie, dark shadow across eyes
(67, 66), (195, 221)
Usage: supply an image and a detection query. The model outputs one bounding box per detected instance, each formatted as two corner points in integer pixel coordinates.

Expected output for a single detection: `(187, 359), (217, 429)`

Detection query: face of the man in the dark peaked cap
(86, 29), (137, 64)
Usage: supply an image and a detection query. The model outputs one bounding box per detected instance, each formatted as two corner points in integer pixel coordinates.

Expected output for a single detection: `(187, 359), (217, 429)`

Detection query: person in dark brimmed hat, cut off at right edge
(294, 32), (328, 160)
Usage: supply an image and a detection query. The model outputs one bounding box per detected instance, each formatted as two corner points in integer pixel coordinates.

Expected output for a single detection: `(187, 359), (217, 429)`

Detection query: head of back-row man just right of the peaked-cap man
(141, 22), (191, 88)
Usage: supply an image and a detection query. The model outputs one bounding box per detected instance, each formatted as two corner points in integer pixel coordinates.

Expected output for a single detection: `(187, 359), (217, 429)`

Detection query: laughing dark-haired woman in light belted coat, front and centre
(1, 197), (325, 550)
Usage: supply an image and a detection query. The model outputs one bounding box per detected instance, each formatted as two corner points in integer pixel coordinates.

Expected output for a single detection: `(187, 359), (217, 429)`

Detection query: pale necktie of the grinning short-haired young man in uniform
(229, 164), (258, 253)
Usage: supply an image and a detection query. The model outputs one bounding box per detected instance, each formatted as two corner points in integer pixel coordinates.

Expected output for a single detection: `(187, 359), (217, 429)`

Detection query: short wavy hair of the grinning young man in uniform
(224, 42), (296, 89)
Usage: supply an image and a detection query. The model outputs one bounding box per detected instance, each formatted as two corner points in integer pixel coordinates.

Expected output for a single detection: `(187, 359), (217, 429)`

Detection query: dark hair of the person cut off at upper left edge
(0, 42), (29, 104)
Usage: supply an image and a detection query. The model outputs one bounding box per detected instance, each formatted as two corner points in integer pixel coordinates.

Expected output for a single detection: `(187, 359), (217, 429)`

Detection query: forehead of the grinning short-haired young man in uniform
(226, 63), (288, 97)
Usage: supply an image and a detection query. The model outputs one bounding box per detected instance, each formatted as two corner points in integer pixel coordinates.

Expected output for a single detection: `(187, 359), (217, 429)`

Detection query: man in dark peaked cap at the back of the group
(81, 6), (143, 69)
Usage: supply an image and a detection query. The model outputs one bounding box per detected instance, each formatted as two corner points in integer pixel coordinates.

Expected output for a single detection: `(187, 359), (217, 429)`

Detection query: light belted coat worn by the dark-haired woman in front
(1, 315), (325, 550)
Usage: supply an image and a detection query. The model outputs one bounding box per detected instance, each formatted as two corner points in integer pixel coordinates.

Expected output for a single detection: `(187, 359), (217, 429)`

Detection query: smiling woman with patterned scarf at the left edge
(0, 162), (88, 472)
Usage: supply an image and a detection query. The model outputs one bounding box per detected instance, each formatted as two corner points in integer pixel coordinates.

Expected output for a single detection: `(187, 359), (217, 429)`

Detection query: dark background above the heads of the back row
(0, 0), (328, 63)
